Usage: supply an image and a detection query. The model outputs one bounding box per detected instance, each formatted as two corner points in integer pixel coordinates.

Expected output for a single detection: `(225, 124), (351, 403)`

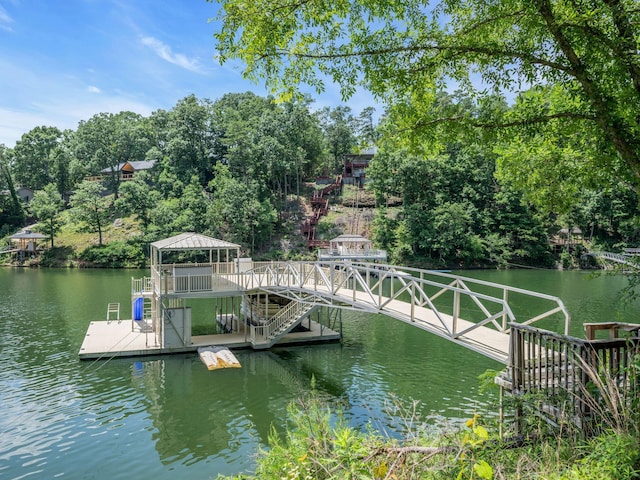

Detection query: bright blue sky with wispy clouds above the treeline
(0, 0), (374, 148)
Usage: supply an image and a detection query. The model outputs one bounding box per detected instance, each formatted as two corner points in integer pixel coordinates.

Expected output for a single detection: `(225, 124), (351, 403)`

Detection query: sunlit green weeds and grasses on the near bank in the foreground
(218, 382), (640, 480)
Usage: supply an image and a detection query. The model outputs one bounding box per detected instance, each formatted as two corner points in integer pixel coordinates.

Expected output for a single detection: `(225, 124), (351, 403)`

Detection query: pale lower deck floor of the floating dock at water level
(79, 320), (340, 360)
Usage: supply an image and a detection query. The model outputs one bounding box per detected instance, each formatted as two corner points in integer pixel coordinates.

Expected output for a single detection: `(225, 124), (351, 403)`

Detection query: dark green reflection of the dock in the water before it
(131, 352), (318, 464)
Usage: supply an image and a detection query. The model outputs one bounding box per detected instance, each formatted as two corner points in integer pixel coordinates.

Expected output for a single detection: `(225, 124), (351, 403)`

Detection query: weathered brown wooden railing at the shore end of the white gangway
(504, 323), (640, 425)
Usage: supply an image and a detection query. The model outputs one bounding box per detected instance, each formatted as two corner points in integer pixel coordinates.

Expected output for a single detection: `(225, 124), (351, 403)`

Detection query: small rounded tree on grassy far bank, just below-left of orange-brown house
(70, 181), (111, 245)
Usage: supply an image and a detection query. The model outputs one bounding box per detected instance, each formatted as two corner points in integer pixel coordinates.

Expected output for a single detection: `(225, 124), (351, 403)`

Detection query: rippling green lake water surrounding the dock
(0, 269), (640, 480)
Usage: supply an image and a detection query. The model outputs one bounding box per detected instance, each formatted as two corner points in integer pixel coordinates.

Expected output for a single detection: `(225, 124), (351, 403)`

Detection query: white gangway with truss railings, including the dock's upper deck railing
(133, 260), (571, 360)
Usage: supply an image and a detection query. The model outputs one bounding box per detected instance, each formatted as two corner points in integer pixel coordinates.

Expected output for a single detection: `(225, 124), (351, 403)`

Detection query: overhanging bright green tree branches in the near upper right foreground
(215, 0), (640, 205)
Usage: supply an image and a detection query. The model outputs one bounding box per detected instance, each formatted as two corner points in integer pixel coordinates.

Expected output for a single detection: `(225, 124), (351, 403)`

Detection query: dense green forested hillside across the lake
(0, 93), (640, 267)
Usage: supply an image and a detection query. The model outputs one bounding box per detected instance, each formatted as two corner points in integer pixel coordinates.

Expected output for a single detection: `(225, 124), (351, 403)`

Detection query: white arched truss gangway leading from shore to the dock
(235, 262), (570, 364)
